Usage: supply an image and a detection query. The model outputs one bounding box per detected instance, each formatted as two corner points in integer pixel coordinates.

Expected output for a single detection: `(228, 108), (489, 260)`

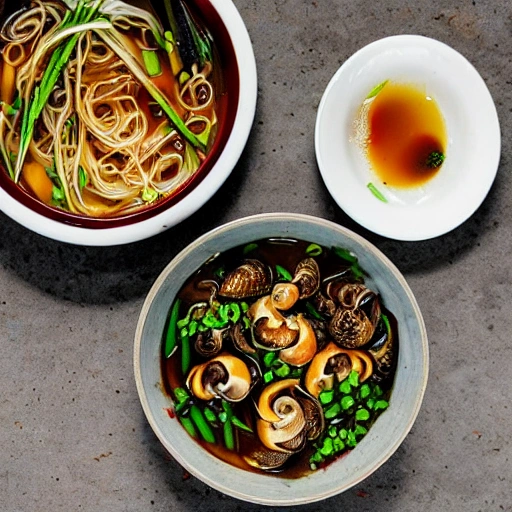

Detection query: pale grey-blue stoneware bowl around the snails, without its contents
(134, 213), (428, 506)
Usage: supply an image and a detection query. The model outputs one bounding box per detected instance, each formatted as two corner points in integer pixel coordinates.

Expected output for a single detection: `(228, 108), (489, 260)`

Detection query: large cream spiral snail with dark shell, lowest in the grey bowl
(256, 379), (323, 453)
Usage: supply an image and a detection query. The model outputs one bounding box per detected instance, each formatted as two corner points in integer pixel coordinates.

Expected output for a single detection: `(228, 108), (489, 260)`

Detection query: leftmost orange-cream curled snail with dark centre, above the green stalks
(187, 353), (252, 402)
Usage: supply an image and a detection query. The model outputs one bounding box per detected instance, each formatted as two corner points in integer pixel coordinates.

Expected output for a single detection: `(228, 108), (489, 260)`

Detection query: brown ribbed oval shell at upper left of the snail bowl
(219, 260), (272, 299)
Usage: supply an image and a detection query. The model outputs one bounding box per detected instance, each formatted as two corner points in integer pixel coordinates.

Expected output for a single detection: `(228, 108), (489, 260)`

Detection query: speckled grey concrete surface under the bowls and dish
(0, 0), (512, 512)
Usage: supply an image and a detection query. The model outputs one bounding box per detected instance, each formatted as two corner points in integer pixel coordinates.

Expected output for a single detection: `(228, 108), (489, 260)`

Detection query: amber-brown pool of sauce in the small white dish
(359, 82), (447, 188)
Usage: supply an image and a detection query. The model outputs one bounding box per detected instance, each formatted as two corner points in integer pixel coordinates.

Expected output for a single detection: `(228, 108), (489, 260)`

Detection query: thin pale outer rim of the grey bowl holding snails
(133, 213), (429, 506)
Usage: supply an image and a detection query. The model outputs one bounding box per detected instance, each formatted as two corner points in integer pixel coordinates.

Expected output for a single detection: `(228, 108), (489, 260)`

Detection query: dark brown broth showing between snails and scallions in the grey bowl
(162, 239), (398, 478)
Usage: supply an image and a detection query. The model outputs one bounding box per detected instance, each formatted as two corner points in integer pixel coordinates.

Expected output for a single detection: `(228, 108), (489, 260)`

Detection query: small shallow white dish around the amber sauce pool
(315, 35), (501, 240)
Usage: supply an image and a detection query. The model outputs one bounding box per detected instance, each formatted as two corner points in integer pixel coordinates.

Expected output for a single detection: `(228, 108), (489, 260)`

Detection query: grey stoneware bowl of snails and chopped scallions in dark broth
(134, 212), (428, 506)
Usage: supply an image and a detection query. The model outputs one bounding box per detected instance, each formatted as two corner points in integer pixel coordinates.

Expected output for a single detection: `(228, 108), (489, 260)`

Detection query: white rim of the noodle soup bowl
(0, 0), (257, 246)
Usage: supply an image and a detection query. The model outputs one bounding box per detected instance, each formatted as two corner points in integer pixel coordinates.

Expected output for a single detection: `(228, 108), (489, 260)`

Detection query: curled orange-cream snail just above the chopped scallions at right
(304, 342), (373, 397)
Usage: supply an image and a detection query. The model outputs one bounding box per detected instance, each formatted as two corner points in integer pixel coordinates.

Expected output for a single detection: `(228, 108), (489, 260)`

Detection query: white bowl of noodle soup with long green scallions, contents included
(0, 0), (257, 245)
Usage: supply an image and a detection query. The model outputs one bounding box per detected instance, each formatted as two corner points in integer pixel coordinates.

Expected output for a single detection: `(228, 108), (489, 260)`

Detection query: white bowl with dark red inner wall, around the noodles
(0, 0), (257, 246)
